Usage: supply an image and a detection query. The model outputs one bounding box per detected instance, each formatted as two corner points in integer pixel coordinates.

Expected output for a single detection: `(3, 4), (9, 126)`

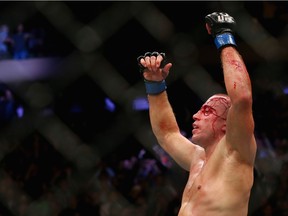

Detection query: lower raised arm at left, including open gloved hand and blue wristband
(138, 52), (204, 171)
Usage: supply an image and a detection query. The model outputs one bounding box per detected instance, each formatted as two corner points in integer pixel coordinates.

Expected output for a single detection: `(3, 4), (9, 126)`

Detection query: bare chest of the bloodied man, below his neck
(180, 156), (251, 215)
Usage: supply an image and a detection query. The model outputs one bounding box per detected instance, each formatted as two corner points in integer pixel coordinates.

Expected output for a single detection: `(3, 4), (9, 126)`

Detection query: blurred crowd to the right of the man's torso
(251, 91), (288, 216)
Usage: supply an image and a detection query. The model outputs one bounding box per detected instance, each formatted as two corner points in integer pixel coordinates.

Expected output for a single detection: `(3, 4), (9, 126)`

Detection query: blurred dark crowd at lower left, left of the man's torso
(0, 133), (186, 216)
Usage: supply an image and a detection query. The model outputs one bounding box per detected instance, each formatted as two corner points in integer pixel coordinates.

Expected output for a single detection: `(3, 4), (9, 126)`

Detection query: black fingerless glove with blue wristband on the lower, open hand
(137, 52), (167, 95)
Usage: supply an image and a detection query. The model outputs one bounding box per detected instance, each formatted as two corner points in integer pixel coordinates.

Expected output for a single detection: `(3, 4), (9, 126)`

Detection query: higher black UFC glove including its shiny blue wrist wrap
(205, 12), (237, 49)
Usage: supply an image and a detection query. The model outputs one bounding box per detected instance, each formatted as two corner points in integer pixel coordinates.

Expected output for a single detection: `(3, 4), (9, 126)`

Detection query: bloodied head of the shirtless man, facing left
(192, 94), (231, 148)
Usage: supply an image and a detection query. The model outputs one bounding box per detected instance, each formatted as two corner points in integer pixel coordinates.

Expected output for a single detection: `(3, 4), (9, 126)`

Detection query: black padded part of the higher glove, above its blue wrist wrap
(205, 12), (236, 38)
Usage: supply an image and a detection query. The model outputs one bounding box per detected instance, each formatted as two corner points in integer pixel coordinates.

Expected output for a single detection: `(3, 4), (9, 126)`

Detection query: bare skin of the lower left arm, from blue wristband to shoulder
(148, 91), (204, 171)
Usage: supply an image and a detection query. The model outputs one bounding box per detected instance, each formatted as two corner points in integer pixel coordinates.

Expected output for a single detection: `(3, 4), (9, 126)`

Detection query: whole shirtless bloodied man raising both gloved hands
(138, 12), (256, 216)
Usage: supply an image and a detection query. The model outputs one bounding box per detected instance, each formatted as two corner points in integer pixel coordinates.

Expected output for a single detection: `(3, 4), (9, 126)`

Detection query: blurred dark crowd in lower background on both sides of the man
(0, 90), (288, 216)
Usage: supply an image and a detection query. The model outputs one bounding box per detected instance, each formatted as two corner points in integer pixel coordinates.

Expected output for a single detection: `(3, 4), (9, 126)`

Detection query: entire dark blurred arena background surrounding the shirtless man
(0, 1), (288, 216)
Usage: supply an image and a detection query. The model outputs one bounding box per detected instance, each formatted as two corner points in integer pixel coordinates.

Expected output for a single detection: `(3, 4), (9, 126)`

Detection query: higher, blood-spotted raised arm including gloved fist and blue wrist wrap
(206, 12), (256, 164)
